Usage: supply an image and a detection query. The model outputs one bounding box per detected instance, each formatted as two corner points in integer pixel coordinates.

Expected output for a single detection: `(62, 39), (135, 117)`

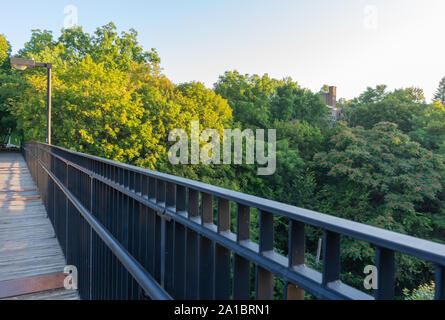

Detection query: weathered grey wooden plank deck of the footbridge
(0, 152), (78, 300)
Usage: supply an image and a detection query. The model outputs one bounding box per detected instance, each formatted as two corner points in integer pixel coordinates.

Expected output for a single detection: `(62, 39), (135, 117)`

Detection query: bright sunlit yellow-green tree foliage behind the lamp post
(11, 24), (232, 168)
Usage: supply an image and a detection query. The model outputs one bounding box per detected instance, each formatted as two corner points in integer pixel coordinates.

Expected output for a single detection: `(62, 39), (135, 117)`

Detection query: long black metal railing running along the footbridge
(23, 143), (445, 300)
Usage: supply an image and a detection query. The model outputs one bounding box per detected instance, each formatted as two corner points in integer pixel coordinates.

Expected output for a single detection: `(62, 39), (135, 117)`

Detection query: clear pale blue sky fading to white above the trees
(0, 0), (445, 100)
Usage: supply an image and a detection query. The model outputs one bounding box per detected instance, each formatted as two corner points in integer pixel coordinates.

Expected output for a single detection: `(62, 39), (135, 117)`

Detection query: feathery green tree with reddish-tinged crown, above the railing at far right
(314, 123), (445, 240)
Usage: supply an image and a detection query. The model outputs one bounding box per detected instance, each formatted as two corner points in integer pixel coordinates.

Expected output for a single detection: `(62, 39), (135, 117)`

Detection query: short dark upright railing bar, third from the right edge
(322, 231), (340, 286)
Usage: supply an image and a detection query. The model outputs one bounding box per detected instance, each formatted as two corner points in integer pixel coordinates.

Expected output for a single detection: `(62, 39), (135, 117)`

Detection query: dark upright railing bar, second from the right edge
(375, 247), (395, 300)
